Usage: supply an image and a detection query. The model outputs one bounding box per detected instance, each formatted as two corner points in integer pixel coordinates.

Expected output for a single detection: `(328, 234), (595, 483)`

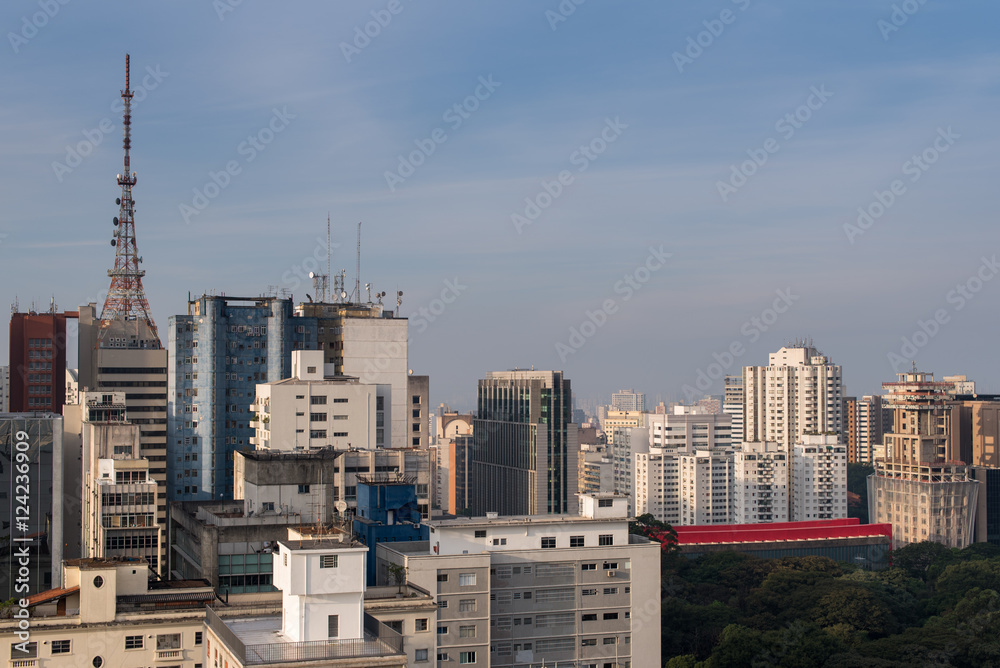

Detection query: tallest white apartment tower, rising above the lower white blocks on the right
(743, 343), (844, 451)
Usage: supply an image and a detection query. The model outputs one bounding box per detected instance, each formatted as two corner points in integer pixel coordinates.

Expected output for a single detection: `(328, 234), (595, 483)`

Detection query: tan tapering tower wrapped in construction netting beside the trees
(868, 370), (979, 548)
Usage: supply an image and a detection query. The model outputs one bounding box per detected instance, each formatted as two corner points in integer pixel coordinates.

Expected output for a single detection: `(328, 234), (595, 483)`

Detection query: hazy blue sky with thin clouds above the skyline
(0, 0), (1000, 407)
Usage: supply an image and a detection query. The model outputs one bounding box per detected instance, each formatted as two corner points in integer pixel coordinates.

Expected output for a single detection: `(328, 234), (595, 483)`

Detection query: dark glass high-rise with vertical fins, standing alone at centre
(470, 370), (580, 515)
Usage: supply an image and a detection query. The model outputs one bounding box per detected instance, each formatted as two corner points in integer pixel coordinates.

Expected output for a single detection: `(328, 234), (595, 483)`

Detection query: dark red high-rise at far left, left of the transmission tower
(6, 308), (76, 415)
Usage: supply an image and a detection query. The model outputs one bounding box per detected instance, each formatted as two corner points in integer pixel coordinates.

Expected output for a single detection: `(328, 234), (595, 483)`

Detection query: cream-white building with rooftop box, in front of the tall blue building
(250, 350), (388, 451)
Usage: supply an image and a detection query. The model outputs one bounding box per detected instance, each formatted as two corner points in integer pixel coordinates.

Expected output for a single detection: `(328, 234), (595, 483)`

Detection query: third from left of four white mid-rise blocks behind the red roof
(733, 443), (790, 524)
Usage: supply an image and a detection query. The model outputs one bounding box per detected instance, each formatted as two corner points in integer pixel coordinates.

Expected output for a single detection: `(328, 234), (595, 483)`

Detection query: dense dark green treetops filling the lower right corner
(662, 543), (1000, 668)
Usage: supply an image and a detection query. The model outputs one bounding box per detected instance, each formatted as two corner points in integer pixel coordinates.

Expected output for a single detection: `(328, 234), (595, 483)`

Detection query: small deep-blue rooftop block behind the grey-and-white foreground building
(354, 479), (430, 587)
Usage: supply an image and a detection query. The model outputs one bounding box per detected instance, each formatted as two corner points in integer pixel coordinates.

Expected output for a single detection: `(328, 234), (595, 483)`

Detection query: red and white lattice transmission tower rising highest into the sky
(101, 54), (162, 348)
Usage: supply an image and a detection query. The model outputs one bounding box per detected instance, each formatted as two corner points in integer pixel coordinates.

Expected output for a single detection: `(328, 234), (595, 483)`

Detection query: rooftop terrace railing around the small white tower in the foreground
(205, 607), (404, 666)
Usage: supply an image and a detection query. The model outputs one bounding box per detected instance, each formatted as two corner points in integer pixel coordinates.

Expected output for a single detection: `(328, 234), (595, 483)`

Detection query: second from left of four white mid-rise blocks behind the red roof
(677, 450), (736, 525)
